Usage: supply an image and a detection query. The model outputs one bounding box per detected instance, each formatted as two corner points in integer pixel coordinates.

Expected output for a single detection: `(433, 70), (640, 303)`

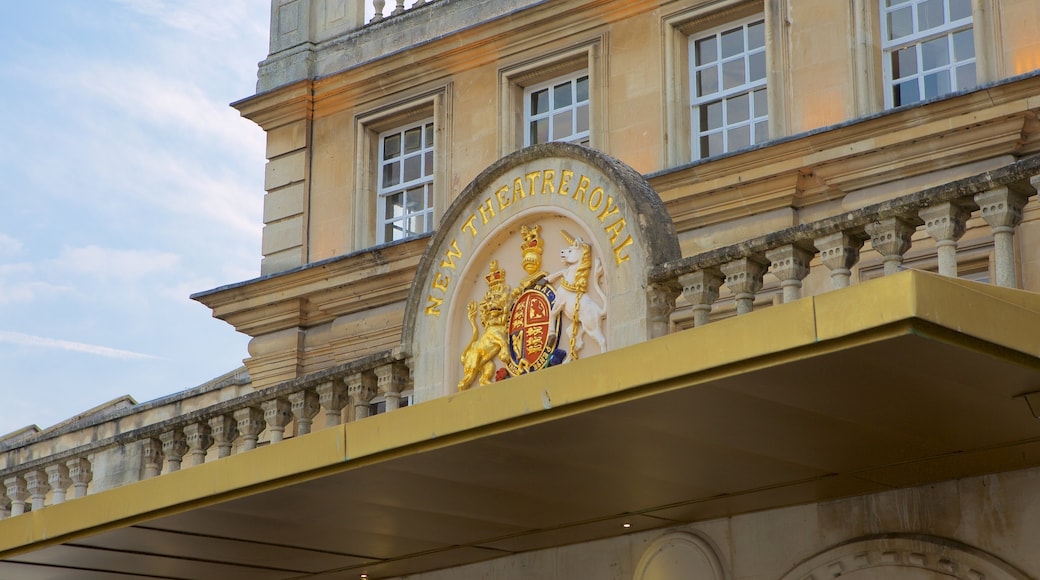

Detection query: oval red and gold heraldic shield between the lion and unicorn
(506, 283), (561, 376)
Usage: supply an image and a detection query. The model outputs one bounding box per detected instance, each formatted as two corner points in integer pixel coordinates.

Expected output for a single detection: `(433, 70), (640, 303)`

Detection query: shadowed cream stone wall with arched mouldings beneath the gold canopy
(402, 459), (1040, 580)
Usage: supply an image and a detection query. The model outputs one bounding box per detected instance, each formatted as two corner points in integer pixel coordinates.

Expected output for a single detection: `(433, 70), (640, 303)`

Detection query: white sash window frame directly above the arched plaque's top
(523, 69), (592, 147)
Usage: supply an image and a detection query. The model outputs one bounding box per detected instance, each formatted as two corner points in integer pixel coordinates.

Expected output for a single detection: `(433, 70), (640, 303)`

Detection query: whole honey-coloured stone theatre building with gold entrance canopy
(0, 0), (1040, 580)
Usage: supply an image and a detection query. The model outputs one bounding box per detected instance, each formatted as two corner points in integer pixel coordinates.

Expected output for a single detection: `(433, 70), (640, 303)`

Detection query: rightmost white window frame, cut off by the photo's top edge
(877, 0), (981, 109)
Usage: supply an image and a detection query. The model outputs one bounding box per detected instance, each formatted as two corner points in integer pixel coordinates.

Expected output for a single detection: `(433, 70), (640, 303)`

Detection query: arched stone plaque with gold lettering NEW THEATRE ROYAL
(404, 143), (679, 401)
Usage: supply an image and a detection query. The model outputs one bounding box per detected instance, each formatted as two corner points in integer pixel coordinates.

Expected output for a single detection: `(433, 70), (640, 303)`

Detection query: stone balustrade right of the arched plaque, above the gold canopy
(649, 156), (1040, 326)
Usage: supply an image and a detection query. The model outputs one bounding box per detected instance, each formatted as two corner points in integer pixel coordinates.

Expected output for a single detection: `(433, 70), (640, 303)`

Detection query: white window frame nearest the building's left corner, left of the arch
(375, 117), (437, 243)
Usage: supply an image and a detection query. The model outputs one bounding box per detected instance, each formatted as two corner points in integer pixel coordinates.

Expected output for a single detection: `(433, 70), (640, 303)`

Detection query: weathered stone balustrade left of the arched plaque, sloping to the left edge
(0, 351), (409, 519)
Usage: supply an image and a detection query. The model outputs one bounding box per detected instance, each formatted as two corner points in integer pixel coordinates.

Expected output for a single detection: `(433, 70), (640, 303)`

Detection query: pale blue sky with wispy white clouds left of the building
(0, 0), (270, 434)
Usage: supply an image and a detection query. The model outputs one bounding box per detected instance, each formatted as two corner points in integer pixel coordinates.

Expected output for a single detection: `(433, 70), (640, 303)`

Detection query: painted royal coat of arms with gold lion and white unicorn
(458, 225), (606, 391)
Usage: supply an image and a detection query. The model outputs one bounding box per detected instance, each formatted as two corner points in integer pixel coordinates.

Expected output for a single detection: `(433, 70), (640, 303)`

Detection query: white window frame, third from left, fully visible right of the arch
(688, 14), (770, 160)
